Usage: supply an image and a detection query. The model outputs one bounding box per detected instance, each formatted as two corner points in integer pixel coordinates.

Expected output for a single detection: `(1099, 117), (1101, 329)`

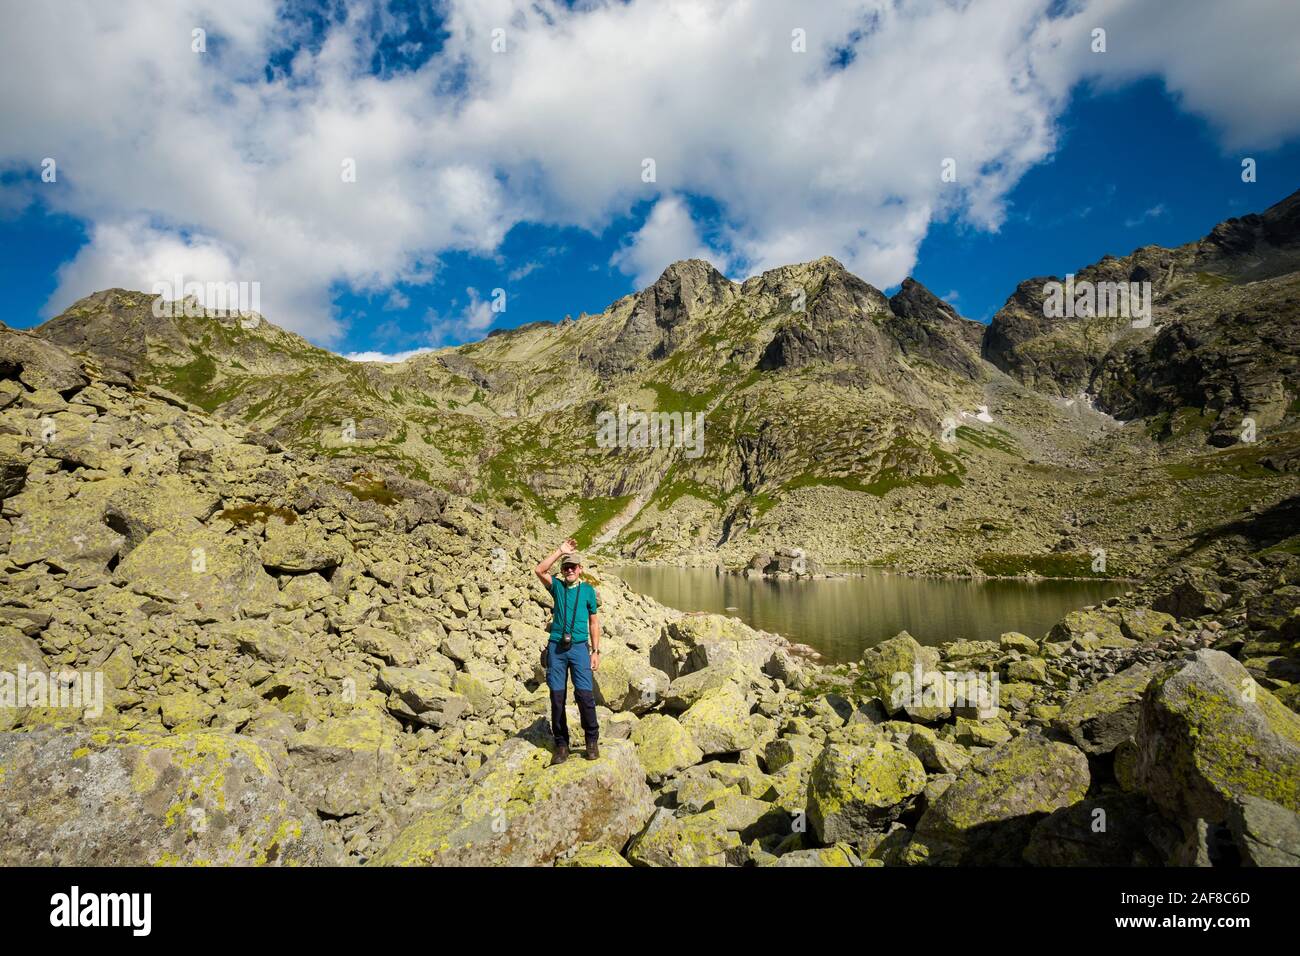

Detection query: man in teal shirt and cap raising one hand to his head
(533, 538), (601, 765)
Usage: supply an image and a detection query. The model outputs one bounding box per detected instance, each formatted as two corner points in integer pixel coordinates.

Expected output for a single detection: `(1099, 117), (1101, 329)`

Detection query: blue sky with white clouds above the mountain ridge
(0, 0), (1300, 355)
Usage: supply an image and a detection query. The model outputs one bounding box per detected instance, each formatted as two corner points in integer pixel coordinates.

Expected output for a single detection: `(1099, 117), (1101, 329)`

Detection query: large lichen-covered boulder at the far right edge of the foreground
(1134, 649), (1300, 823)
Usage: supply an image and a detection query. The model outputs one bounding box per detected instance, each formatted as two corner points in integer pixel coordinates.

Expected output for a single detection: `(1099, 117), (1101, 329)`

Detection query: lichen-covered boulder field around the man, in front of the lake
(0, 330), (1300, 866)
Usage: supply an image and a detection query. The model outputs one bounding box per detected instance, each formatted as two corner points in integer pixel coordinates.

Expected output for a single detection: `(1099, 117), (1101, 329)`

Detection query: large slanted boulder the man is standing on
(371, 737), (654, 866)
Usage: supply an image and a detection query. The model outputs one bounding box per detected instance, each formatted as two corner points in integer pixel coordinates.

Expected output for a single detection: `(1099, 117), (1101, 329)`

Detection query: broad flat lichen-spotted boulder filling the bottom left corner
(0, 730), (339, 866)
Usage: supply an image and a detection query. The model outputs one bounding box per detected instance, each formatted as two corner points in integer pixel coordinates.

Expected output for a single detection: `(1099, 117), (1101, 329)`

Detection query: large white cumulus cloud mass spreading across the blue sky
(0, 0), (1300, 343)
